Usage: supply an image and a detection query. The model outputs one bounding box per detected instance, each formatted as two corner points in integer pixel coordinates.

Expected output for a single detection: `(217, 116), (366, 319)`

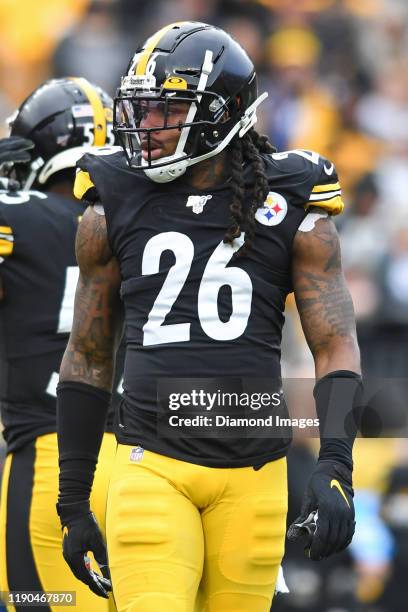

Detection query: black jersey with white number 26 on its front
(75, 149), (343, 467)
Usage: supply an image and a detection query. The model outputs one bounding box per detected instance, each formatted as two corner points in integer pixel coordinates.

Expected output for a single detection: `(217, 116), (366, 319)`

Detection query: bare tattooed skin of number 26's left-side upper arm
(60, 207), (122, 391)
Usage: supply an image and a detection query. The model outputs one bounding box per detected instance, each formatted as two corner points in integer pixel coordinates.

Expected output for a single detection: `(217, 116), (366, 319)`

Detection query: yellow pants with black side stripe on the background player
(0, 433), (116, 612)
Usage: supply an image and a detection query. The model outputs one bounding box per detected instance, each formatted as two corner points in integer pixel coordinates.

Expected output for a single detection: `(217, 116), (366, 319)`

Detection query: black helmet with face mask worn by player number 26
(114, 21), (267, 182)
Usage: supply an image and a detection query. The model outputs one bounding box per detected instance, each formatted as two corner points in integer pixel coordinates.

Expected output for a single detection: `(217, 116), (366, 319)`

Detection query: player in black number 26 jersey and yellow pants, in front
(57, 22), (361, 612)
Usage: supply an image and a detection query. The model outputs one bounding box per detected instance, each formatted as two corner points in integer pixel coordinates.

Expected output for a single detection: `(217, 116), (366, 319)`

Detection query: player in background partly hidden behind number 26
(0, 78), (120, 612)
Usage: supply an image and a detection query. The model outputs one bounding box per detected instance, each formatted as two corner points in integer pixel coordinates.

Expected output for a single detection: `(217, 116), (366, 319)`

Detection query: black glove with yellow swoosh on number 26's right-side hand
(287, 460), (355, 561)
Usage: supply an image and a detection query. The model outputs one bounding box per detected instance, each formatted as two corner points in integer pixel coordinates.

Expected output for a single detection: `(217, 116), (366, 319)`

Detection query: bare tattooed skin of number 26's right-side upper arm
(292, 211), (360, 378)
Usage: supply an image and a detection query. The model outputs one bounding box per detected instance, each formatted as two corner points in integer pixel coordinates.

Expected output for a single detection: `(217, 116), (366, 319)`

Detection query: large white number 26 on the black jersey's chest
(142, 232), (252, 346)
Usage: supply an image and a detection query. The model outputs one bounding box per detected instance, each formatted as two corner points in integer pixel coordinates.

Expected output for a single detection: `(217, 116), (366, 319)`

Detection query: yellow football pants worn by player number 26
(106, 445), (287, 612)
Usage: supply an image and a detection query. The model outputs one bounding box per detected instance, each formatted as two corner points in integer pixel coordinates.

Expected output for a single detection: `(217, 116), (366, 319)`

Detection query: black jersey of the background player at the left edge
(0, 191), (122, 451)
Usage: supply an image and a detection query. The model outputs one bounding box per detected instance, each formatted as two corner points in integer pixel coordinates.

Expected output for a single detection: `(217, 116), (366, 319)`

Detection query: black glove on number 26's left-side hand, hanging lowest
(57, 503), (112, 598)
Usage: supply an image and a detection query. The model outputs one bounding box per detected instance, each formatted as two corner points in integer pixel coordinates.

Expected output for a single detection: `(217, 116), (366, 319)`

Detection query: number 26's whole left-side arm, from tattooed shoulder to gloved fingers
(57, 203), (122, 598)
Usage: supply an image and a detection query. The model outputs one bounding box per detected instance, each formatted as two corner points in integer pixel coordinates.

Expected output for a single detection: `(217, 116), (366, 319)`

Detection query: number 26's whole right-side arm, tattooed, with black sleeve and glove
(288, 211), (361, 561)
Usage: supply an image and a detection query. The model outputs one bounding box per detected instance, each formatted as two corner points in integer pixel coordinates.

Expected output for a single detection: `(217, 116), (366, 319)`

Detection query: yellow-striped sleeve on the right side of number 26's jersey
(305, 157), (344, 215)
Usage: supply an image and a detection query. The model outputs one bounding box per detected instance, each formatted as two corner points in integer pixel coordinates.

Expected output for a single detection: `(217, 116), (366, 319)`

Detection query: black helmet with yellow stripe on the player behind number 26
(9, 77), (114, 189)
